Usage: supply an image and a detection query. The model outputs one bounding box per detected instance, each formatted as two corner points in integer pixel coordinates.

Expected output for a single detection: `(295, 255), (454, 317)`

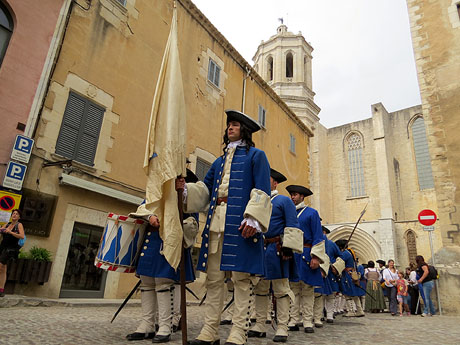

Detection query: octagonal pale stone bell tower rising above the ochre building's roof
(253, 24), (321, 130)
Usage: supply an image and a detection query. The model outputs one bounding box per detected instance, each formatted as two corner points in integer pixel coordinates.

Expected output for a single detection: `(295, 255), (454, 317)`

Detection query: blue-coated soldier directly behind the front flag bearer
(248, 169), (299, 343)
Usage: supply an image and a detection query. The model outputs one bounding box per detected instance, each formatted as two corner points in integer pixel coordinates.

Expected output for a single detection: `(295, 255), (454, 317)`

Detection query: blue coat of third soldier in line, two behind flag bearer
(291, 206), (324, 286)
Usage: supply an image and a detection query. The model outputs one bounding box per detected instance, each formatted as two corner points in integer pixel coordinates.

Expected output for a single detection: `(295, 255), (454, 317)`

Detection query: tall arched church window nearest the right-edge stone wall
(412, 117), (434, 190)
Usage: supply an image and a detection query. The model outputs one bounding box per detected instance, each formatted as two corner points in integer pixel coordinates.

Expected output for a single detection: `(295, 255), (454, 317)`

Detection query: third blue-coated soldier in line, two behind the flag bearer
(286, 185), (329, 333)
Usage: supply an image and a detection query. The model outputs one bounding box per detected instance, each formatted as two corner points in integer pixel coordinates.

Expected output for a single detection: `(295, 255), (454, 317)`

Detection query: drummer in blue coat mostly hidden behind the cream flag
(126, 169), (198, 343)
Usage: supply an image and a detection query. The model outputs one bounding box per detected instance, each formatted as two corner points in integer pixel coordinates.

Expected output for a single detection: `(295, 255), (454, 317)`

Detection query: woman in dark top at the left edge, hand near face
(0, 209), (25, 297)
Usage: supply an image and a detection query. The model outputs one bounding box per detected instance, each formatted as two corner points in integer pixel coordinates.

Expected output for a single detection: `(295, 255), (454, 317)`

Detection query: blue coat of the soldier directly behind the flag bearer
(265, 194), (299, 280)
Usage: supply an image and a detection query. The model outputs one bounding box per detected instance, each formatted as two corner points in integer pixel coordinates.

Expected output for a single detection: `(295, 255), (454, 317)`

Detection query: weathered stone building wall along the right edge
(407, 0), (460, 314)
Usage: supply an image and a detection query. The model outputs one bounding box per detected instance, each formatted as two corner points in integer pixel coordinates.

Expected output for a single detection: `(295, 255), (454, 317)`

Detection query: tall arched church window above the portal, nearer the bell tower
(347, 133), (365, 197)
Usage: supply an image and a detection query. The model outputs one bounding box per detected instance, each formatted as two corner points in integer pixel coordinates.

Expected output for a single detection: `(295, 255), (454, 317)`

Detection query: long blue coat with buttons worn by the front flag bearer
(197, 146), (270, 275)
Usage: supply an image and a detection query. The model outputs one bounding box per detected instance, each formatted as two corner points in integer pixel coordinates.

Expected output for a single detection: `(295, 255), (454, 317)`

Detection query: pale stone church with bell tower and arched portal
(253, 25), (441, 267)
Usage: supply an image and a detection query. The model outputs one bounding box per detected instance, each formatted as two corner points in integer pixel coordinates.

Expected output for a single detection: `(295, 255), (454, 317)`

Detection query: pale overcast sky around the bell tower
(192, 0), (421, 128)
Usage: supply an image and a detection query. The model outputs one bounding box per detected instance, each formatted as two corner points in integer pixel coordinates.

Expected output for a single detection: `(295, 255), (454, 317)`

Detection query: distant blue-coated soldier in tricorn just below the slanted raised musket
(335, 240), (365, 317)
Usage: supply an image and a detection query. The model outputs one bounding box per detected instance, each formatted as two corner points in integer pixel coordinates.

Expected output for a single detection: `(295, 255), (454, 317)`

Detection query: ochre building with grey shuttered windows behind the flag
(7, 0), (312, 298)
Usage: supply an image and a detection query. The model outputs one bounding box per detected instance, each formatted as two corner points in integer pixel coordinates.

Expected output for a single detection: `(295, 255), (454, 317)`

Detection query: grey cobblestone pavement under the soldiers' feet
(0, 306), (460, 345)
